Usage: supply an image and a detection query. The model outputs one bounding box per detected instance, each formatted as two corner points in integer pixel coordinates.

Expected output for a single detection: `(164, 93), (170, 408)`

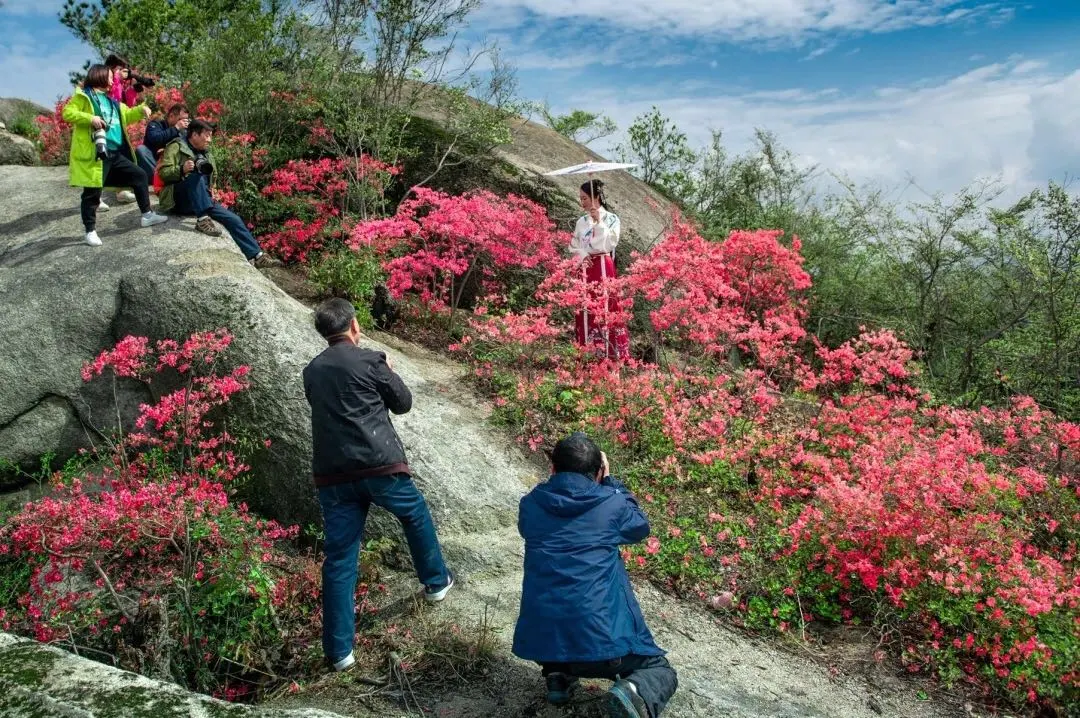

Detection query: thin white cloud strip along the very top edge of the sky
(484, 0), (1012, 42)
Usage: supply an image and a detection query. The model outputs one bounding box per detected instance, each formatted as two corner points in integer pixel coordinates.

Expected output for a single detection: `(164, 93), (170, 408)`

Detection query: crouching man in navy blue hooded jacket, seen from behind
(513, 433), (678, 718)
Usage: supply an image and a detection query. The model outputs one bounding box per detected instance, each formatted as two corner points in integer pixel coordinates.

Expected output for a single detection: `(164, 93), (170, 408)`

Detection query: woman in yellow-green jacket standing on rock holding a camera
(64, 65), (168, 247)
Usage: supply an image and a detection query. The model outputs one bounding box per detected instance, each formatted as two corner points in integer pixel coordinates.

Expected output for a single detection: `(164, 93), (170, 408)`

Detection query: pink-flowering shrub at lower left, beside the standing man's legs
(0, 330), (319, 699)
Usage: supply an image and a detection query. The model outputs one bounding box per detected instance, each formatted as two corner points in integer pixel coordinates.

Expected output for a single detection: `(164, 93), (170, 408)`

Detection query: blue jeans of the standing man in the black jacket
(319, 474), (450, 662)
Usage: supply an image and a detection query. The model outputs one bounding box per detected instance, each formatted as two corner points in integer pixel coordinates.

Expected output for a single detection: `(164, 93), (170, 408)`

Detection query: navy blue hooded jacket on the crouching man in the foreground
(513, 473), (664, 663)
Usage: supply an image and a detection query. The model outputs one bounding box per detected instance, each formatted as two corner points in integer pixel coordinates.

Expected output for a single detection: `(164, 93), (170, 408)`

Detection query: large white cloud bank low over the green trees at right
(578, 60), (1080, 197)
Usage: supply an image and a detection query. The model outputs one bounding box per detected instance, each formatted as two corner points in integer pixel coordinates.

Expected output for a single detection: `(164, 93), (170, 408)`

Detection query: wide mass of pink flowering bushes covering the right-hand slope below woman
(347, 207), (1080, 706)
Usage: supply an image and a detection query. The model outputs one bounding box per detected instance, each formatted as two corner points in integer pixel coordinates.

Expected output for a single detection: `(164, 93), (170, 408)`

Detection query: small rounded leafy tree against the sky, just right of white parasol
(616, 105), (697, 193)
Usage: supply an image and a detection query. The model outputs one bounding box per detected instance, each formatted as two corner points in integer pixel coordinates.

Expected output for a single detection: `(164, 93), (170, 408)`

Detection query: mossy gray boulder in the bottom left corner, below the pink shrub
(0, 633), (340, 718)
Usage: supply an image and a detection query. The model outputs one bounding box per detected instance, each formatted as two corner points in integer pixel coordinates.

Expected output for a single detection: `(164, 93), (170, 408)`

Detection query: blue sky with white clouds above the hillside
(0, 0), (1080, 199)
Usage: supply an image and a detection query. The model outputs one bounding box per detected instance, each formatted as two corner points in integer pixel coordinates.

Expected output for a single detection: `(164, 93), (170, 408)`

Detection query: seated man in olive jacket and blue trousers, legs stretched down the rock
(158, 120), (281, 269)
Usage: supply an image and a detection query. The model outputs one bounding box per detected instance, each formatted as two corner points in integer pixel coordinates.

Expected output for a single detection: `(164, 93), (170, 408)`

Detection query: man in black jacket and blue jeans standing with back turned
(303, 299), (454, 670)
